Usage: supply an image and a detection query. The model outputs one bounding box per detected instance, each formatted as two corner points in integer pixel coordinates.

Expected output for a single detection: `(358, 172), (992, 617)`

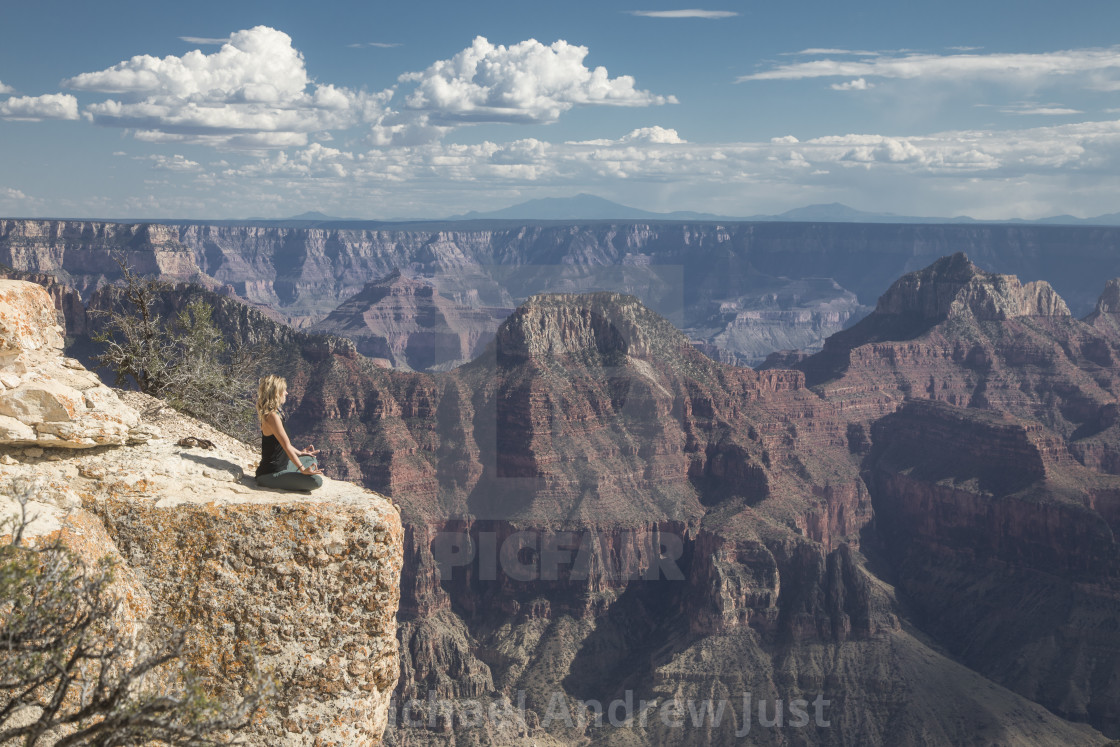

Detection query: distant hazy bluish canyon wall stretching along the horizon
(8, 221), (1120, 364)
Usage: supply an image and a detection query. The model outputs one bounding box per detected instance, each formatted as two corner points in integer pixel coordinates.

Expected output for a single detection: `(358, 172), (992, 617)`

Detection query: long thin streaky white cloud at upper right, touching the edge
(737, 47), (1120, 86)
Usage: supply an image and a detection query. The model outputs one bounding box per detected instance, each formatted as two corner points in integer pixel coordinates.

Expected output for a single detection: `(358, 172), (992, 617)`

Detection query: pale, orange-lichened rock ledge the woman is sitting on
(0, 281), (403, 745)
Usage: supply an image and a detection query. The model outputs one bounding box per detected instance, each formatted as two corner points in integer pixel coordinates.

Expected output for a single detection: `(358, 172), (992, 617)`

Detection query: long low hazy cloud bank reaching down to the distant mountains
(128, 114), (1120, 217)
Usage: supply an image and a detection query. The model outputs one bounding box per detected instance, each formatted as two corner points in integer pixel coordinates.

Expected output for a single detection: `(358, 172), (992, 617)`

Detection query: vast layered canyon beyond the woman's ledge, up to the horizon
(0, 216), (1120, 745)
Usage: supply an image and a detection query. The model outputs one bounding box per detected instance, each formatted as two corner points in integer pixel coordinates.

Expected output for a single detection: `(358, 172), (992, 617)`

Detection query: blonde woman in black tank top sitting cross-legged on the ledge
(256, 375), (323, 491)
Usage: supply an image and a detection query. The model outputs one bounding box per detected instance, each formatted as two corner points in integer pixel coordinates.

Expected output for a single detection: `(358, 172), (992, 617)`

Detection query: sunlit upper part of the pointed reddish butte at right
(796, 253), (1112, 430)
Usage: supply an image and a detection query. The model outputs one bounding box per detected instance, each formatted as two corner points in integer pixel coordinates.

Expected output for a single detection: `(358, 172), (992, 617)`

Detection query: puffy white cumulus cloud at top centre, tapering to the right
(400, 36), (676, 124)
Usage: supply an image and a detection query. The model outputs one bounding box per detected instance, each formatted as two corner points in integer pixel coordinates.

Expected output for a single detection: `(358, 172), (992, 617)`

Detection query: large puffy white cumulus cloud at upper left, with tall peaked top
(63, 26), (392, 148)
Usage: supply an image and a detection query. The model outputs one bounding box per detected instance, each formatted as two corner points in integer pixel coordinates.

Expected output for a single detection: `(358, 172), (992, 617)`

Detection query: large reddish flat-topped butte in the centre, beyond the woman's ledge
(247, 284), (1103, 745)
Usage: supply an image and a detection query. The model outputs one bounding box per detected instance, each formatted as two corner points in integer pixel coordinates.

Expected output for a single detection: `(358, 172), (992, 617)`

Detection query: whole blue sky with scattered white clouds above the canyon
(0, 0), (1120, 218)
